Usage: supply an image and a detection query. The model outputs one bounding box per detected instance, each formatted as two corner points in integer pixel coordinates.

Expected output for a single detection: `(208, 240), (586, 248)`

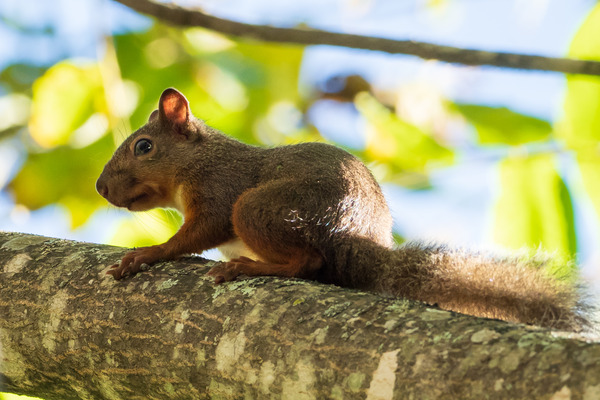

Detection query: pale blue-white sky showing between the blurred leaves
(0, 0), (599, 272)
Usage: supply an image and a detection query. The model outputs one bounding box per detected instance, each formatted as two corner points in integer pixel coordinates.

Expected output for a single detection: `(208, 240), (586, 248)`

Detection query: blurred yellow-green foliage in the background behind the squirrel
(0, 1), (600, 264)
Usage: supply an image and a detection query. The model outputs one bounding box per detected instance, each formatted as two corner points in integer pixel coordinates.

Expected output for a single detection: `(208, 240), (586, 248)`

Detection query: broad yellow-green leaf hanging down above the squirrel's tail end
(495, 155), (577, 256)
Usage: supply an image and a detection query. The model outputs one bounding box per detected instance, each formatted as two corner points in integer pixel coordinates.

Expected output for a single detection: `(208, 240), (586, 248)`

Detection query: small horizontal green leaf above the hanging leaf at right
(455, 104), (552, 146)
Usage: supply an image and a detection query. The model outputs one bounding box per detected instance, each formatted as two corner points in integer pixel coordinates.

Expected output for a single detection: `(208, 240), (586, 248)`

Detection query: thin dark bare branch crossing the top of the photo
(115, 0), (600, 75)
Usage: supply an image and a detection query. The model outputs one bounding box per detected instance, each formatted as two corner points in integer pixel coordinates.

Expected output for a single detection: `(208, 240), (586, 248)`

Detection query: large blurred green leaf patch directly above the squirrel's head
(115, 24), (304, 143)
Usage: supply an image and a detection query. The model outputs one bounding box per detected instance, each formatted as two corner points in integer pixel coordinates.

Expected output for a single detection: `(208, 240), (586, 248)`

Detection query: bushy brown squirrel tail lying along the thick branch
(332, 238), (592, 331)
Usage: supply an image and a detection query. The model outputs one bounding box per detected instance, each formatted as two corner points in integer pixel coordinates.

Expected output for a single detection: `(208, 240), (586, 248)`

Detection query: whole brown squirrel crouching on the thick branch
(96, 89), (587, 330)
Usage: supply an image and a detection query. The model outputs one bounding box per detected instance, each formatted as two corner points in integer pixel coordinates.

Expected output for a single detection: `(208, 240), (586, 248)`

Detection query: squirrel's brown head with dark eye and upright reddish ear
(96, 88), (203, 211)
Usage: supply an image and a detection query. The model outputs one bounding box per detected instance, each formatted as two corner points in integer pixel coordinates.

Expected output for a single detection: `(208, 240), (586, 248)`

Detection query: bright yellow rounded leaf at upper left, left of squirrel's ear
(29, 62), (106, 148)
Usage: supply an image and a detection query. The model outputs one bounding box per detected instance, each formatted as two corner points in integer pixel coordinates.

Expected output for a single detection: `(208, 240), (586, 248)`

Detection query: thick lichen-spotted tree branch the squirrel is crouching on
(0, 233), (600, 399)
